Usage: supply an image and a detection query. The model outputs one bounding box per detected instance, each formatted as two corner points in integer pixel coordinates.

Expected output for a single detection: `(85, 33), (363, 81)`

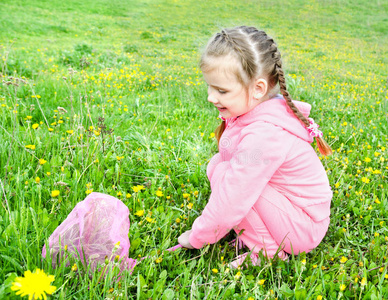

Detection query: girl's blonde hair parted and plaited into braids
(200, 26), (332, 155)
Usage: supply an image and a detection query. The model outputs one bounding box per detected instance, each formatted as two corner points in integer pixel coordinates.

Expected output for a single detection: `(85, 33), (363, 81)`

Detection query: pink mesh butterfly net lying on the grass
(42, 193), (181, 271)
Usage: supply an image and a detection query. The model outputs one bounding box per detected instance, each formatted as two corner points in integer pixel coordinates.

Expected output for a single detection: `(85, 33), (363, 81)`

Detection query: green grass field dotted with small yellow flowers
(0, 0), (388, 299)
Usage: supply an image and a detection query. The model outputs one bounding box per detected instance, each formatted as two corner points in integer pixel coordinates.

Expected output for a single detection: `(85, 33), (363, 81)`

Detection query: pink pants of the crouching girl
(236, 185), (330, 257)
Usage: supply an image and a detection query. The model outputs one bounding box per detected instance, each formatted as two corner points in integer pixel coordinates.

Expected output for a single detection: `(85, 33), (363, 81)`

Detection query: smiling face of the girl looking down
(203, 57), (258, 119)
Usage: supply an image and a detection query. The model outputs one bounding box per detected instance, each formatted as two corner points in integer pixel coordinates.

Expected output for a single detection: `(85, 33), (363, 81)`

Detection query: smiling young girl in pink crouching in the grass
(178, 26), (332, 267)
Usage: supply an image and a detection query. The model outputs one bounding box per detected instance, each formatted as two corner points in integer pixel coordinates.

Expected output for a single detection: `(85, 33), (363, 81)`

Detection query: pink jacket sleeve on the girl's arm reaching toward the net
(189, 125), (289, 248)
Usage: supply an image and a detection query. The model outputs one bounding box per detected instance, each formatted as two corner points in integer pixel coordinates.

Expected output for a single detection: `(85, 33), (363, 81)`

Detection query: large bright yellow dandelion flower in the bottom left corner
(11, 269), (57, 300)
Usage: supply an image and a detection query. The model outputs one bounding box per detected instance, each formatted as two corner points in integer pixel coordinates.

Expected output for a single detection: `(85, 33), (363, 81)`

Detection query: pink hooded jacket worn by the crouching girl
(189, 95), (332, 248)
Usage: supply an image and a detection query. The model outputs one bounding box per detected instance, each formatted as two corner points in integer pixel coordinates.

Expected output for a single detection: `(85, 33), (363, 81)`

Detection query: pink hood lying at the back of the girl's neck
(238, 95), (314, 143)
